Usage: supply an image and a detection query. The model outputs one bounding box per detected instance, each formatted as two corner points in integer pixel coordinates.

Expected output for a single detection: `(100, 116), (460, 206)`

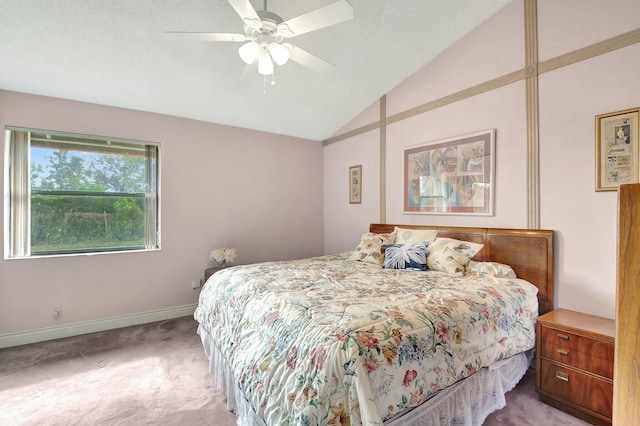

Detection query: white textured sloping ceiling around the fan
(0, 0), (510, 140)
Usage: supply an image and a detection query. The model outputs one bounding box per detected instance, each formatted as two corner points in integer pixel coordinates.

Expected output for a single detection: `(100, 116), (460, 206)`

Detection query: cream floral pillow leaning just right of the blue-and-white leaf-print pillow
(427, 238), (484, 275)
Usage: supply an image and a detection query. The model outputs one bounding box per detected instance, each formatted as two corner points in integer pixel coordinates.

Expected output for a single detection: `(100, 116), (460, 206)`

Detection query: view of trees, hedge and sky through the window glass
(31, 140), (146, 254)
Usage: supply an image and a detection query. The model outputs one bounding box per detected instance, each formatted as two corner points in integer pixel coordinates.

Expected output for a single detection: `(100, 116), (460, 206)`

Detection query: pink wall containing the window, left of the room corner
(0, 90), (324, 334)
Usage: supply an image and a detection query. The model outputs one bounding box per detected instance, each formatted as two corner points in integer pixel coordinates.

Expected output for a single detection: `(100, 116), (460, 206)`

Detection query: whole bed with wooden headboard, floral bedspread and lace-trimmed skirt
(194, 224), (553, 426)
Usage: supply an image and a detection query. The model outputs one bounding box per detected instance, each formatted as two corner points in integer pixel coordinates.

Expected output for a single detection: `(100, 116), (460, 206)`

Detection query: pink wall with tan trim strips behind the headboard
(324, 0), (640, 318)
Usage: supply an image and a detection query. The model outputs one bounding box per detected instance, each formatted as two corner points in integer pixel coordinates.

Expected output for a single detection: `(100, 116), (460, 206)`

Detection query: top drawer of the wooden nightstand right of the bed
(541, 327), (614, 379)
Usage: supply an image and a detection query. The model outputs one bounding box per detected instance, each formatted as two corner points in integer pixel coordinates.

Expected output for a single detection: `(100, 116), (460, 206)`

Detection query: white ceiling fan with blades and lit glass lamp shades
(165, 0), (353, 84)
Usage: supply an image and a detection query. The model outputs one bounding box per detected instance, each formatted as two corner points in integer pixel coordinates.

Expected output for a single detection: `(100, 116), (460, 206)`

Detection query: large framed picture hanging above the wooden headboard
(404, 129), (495, 216)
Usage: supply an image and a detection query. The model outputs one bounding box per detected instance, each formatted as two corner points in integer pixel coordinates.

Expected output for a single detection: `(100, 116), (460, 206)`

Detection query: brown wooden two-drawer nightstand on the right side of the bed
(536, 309), (616, 425)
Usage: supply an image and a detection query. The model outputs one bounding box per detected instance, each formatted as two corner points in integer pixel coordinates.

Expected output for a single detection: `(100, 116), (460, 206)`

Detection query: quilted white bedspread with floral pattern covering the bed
(195, 253), (537, 425)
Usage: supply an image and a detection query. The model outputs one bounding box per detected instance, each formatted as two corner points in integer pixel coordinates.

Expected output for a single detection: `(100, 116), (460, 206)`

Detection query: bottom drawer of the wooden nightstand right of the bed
(540, 360), (613, 419)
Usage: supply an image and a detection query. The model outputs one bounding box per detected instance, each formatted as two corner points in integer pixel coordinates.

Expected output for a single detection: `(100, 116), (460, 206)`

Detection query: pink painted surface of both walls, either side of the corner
(0, 0), (640, 334)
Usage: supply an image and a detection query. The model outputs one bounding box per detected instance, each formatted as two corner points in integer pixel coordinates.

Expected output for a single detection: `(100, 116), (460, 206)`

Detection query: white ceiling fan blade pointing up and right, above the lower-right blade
(278, 0), (353, 38)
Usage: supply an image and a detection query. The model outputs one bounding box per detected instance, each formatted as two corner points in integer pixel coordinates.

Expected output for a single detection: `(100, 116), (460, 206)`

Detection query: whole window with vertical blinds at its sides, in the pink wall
(5, 127), (160, 258)
